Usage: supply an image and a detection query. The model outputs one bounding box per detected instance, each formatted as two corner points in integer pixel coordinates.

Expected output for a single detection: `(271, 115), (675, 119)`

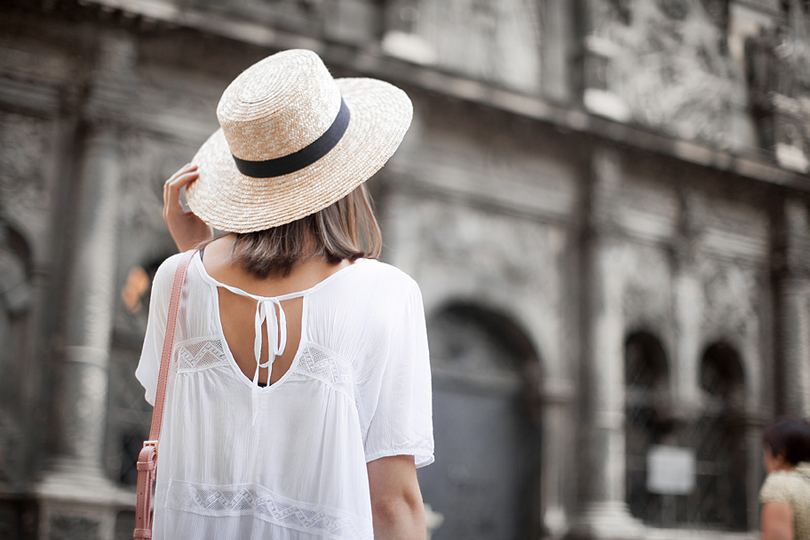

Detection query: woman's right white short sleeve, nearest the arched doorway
(360, 271), (433, 467)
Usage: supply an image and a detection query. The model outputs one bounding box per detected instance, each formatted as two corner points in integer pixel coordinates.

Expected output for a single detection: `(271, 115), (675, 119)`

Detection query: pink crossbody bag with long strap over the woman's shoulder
(133, 250), (197, 540)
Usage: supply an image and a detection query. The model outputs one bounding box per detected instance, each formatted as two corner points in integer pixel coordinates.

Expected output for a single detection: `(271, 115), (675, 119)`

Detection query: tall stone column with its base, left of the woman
(36, 33), (134, 540)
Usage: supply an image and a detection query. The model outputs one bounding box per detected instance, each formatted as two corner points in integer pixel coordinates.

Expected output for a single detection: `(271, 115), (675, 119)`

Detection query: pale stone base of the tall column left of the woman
(34, 460), (135, 540)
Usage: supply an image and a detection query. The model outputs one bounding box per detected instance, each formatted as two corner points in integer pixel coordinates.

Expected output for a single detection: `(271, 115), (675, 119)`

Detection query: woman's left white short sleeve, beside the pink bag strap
(135, 255), (179, 406)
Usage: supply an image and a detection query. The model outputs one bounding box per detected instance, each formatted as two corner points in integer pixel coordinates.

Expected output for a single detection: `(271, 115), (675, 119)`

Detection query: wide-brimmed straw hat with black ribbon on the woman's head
(186, 49), (413, 232)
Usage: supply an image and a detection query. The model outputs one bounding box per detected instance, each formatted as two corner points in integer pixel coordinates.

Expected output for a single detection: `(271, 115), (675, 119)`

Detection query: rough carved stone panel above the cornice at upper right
(585, 0), (745, 146)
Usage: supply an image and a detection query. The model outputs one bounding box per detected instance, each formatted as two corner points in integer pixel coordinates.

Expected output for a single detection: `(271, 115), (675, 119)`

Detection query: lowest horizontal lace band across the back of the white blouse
(166, 481), (373, 540)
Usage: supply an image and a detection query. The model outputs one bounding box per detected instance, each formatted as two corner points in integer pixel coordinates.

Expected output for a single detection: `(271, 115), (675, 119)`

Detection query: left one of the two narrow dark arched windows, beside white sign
(624, 330), (677, 525)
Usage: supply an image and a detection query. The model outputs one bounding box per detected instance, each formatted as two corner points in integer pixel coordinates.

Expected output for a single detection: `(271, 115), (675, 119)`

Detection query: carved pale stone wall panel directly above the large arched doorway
(383, 195), (570, 376)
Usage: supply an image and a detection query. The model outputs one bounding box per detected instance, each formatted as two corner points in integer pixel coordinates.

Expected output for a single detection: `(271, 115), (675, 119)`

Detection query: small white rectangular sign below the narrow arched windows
(647, 445), (695, 495)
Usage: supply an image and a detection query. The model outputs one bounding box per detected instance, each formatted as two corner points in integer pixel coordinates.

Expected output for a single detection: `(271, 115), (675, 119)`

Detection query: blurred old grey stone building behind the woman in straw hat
(0, 0), (810, 540)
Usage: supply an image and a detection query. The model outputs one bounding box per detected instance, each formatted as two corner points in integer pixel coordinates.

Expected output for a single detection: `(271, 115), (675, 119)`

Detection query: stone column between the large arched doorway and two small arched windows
(574, 149), (643, 539)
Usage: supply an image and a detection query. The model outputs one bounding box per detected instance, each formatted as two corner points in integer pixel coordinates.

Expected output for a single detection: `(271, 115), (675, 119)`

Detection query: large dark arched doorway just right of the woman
(419, 304), (540, 540)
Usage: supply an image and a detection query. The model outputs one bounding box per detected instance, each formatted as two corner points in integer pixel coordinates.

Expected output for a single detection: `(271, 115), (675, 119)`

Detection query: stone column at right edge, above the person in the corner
(776, 200), (810, 417)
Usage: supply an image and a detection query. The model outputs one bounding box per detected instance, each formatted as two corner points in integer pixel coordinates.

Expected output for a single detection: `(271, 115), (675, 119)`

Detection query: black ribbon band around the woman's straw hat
(233, 98), (351, 178)
